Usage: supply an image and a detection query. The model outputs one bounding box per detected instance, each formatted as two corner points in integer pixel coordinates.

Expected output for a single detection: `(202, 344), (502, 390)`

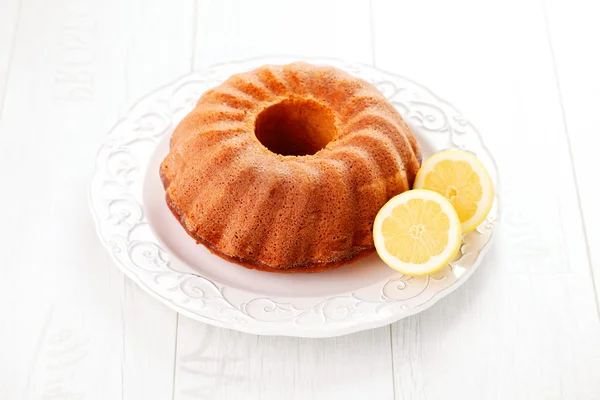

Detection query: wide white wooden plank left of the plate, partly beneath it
(0, 0), (193, 399)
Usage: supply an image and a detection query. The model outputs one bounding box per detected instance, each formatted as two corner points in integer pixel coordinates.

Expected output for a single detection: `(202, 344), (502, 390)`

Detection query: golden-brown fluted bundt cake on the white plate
(160, 63), (421, 272)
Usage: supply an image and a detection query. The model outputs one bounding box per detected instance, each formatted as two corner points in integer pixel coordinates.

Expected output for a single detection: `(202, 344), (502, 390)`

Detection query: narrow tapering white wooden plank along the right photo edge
(545, 0), (600, 305)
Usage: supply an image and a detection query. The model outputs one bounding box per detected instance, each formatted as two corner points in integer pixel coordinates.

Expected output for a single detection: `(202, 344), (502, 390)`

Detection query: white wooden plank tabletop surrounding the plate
(0, 0), (600, 400)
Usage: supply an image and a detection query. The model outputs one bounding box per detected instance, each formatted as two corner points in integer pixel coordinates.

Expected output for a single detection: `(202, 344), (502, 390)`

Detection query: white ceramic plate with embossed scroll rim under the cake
(90, 58), (499, 337)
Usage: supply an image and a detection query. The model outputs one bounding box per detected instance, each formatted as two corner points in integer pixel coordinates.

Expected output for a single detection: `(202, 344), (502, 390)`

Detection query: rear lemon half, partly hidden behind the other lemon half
(414, 150), (494, 233)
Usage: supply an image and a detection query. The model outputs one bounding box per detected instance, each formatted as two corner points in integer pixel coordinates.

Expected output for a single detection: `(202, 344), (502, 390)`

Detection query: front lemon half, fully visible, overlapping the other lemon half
(373, 190), (462, 275)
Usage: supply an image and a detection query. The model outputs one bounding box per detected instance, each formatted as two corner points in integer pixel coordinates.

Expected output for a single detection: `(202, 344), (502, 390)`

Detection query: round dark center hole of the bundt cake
(254, 98), (336, 156)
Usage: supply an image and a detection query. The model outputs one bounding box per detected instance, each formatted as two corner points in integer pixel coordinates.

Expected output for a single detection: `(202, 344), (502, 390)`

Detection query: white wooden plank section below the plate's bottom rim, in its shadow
(175, 317), (393, 400)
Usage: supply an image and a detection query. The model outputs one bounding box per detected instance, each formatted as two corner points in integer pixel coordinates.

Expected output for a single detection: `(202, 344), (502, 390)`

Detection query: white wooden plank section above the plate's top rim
(194, 0), (372, 69)
